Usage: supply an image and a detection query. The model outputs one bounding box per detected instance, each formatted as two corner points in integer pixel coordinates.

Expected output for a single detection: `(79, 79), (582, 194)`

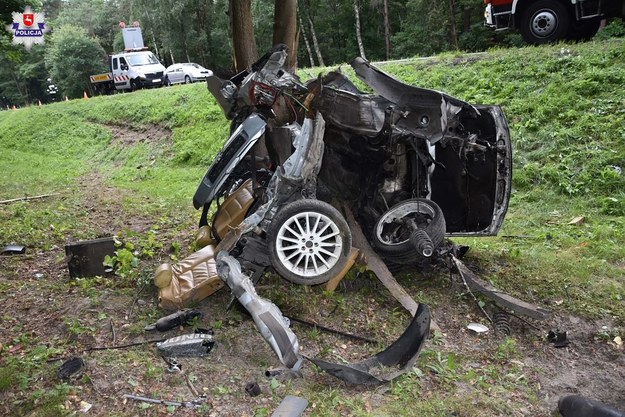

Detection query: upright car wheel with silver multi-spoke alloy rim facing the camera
(268, 199), (352, 285)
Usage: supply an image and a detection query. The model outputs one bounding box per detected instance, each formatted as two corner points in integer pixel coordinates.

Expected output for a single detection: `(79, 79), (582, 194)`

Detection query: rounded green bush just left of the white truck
(45, 25), (107, 97)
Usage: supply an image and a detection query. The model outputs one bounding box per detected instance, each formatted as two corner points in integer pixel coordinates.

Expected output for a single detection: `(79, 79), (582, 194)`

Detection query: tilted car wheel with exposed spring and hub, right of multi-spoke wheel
(372, 198), (446, 264)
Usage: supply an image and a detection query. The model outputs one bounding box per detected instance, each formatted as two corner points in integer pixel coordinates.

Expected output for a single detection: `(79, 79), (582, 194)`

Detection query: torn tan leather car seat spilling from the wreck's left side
(154, 180), (254, 309)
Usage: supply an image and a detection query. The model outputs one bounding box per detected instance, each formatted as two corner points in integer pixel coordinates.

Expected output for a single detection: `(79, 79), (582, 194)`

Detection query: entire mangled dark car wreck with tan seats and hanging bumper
(155, 46), (512, 384)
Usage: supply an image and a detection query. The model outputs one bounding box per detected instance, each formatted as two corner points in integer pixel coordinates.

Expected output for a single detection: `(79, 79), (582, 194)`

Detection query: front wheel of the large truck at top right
(520, 0), (571, 45)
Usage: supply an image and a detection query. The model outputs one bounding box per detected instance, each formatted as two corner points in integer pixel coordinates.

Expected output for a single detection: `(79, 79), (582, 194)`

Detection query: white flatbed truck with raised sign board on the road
(89, 23), (165, 94)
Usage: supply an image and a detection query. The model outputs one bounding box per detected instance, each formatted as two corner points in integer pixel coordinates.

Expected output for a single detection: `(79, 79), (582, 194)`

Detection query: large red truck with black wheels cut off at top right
(484, 0), (625, 44)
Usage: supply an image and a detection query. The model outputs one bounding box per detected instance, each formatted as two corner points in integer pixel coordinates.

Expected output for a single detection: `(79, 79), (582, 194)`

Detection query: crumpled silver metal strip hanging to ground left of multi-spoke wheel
(217, 251), (302, 369)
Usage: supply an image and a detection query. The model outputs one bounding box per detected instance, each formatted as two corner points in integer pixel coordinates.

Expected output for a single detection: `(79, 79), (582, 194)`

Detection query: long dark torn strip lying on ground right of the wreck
(450, 255), (551, 320)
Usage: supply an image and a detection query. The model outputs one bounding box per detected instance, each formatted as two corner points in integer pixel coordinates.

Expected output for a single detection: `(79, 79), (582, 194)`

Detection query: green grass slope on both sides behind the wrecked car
(0, 40), (625, 319)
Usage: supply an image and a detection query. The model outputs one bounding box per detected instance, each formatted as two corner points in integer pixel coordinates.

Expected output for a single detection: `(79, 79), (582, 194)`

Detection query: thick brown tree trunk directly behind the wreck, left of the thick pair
(230, 0), (258, 71)
